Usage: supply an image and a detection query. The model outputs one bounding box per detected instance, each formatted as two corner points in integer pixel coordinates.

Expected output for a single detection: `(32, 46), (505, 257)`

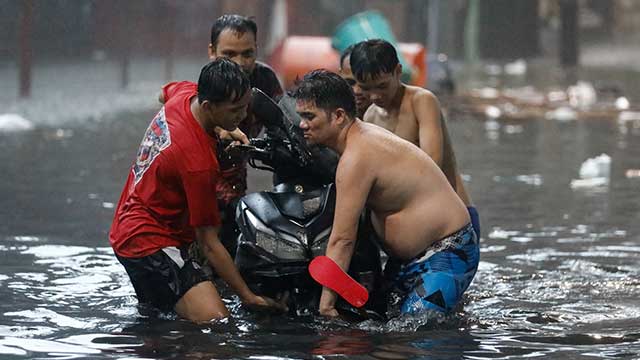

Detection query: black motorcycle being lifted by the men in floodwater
(235, 88), (386, 320)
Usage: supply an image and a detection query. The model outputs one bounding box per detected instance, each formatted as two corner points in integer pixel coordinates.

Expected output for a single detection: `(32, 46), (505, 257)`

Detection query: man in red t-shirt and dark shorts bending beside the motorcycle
(109, 59), (283, 321)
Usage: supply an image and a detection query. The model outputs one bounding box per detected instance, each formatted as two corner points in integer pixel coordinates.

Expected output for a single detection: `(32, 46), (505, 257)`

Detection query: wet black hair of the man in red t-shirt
(198, 58), (251, 104)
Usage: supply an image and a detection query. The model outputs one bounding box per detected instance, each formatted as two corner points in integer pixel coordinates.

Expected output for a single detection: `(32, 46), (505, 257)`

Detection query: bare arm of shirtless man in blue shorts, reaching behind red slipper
(319, 150), (373, 316)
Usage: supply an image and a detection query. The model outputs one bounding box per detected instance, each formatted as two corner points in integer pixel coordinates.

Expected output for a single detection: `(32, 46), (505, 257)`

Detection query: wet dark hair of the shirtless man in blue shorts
(291, 69), (356, 118)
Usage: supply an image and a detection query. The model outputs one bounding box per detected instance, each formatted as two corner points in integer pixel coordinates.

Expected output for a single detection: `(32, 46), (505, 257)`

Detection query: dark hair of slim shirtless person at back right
(349, 39), (399, 81)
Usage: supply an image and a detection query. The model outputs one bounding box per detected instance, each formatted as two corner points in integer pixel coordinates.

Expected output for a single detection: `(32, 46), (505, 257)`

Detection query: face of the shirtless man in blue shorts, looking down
(296, 100), (333, 145)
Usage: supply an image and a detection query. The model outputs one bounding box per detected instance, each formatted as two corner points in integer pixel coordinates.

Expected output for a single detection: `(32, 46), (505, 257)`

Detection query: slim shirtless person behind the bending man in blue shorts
(349, 39), (480, 236)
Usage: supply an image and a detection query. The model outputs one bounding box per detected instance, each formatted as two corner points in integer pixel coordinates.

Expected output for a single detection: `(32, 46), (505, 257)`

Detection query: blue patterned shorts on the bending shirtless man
(396, 224), (480, 313)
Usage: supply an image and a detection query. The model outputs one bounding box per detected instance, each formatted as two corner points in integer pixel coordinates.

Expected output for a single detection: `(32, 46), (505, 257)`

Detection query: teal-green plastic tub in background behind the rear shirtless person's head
(331, 10), (413, 83)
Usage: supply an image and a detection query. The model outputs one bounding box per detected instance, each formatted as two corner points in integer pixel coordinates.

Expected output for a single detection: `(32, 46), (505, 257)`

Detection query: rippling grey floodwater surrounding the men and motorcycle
(0, 64), (640, 359)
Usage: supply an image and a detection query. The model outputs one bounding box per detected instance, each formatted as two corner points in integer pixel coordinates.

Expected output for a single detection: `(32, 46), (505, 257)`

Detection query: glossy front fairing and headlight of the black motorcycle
(236, 184), (335, 276)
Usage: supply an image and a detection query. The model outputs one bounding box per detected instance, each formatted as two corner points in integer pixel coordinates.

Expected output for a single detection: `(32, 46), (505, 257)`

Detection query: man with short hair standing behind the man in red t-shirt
(209, 14), (283, 255)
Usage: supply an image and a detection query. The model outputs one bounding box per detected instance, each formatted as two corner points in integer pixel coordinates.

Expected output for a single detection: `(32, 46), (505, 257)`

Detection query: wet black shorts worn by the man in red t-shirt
(116, 247), (209, 311)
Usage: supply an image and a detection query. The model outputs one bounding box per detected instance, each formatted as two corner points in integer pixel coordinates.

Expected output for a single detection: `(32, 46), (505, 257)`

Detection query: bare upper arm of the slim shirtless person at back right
(411, 90), (443, 167)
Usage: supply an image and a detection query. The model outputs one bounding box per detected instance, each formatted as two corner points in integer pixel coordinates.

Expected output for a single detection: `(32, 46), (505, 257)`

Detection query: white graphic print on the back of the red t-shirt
(133, 108), (171, 184)
